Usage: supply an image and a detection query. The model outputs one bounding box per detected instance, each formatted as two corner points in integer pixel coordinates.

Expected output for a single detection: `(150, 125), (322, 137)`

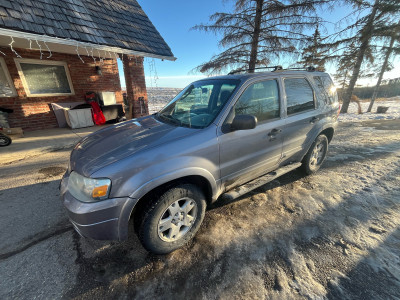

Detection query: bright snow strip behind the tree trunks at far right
(339, 96), (400, 122)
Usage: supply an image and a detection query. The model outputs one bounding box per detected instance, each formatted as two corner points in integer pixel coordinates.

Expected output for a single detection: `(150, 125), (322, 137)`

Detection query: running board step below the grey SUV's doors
(221, 163), (301, 201)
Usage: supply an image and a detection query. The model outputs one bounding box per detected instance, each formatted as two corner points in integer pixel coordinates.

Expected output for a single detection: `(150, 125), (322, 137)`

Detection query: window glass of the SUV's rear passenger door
(284, 78), (315, 115)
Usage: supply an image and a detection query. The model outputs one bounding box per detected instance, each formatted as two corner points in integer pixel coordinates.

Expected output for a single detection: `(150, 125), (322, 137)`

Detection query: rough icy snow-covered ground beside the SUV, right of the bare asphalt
(52, 120), (400, 300)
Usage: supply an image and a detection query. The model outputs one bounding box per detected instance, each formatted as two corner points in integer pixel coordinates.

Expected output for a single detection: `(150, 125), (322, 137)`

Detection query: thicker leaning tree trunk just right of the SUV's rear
(340, 0), (379, 114)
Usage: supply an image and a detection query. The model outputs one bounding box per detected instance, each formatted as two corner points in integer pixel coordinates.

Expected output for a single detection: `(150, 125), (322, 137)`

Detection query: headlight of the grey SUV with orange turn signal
(67, 172), (111, 202)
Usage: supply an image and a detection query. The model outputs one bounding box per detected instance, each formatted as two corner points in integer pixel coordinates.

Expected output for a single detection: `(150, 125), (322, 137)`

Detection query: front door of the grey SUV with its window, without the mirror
(218, 78), (285, 190)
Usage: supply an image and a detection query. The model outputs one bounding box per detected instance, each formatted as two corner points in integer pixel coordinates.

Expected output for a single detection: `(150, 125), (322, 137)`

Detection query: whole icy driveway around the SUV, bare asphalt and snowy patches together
(0, 120), (400, 299)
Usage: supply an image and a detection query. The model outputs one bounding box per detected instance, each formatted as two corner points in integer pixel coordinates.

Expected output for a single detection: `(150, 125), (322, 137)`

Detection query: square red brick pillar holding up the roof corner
(123, 55), (149, 119)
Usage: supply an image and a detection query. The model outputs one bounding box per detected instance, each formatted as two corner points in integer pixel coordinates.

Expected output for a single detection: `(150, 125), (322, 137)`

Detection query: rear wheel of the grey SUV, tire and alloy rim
(301, 134), (329, 175)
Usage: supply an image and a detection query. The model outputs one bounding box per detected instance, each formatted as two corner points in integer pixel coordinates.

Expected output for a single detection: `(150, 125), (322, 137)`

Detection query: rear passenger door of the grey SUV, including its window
(282, 75), (319, 160)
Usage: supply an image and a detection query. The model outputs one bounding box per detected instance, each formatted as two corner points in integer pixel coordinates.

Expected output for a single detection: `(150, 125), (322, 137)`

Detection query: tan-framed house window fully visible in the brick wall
(15, 58), (74, 97)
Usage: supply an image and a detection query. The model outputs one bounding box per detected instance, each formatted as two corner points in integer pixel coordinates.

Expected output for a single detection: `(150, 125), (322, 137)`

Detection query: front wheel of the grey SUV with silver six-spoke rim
(138, 184), (206, 254)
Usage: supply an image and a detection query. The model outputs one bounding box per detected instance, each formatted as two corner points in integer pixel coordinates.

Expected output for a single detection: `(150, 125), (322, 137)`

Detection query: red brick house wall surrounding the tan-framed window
(0, 48), (123, 130)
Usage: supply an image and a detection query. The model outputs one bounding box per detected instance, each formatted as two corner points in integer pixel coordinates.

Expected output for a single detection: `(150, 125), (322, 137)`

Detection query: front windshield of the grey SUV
(156, 79), (240, 128)
